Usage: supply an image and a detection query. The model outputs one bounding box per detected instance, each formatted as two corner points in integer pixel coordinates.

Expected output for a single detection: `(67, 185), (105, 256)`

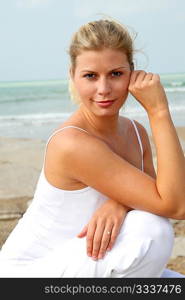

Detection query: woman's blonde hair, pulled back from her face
(68, 19), (134, 103)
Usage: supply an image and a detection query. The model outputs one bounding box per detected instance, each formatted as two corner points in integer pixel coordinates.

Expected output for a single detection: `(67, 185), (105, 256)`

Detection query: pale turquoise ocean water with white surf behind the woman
(0, 73), (185, 140)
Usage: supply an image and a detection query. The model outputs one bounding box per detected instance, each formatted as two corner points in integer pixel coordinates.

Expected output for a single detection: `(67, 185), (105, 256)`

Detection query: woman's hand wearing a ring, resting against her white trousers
(78, 199), (129, 260)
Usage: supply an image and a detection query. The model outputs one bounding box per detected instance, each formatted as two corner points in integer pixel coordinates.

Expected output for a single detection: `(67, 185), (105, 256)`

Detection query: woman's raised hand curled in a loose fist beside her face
(128, 70), (168, 114)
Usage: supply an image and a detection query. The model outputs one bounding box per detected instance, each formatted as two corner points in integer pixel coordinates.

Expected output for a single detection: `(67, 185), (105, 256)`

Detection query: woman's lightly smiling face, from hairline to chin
(71, 49), (131, 115)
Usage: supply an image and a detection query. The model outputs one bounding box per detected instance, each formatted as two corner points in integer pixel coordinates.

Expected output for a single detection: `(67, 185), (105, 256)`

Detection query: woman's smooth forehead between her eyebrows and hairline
(76, 49), (128, 70)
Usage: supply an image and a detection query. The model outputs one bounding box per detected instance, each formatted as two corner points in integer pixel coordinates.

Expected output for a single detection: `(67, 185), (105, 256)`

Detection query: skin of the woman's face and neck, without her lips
(71, 49), (131, 137)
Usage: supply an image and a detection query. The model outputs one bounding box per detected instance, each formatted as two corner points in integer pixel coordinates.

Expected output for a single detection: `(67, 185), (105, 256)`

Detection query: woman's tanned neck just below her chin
(78, 105), (119, 137)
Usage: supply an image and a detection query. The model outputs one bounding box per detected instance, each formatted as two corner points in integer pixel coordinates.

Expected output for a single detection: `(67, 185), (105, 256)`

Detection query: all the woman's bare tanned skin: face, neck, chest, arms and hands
(45, 49), (185, 259)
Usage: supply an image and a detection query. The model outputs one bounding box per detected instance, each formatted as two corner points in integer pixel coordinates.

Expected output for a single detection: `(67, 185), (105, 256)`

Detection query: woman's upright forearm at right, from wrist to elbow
(149, 108), (185, 212)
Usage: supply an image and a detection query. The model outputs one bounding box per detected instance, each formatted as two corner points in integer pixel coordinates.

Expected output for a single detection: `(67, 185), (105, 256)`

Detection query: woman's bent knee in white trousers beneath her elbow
(115, 210), (174, 277)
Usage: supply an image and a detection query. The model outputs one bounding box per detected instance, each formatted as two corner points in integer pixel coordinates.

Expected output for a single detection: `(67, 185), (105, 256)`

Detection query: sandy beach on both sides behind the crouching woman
(0, 127), (185, 274)
